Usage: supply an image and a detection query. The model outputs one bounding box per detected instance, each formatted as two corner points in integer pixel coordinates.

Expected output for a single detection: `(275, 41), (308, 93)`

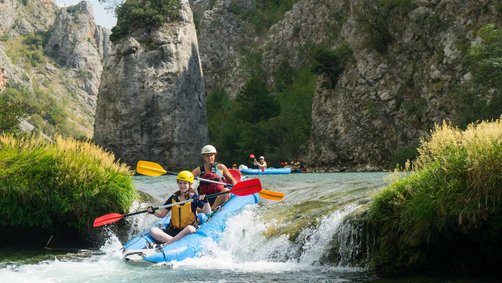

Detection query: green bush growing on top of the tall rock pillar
(110, 0), (180, 42)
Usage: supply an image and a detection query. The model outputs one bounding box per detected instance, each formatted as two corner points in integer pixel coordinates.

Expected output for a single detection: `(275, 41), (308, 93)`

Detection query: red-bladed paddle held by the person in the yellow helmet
(94, 179), (261, 227)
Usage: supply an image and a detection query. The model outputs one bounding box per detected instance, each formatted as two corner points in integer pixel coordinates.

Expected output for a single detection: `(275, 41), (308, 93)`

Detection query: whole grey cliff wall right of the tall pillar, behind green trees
(193, 0), (500, 171)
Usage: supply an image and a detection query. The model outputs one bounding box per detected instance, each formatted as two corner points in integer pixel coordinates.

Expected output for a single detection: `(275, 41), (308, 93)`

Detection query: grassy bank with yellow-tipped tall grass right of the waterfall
(370, 119), (502, 273)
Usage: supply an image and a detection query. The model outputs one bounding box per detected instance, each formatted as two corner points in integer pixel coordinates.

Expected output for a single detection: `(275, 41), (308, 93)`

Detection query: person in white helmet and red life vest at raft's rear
(192, 144), (237, 209)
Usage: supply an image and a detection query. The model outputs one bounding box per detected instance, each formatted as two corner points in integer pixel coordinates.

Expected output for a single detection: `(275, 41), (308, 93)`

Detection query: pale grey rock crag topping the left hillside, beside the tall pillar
(45, 1), (111, 104)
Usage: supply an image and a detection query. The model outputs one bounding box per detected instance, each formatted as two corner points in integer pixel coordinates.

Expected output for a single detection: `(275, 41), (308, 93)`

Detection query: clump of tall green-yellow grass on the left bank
(0, 135), (136, 231)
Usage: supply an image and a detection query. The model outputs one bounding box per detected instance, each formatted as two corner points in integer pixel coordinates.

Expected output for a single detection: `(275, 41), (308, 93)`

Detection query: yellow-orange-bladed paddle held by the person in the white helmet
(136, 160), (284, 200)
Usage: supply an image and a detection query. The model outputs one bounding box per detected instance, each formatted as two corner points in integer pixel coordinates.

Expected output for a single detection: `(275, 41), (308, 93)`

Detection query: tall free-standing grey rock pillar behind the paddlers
(94, 1), (207, 169)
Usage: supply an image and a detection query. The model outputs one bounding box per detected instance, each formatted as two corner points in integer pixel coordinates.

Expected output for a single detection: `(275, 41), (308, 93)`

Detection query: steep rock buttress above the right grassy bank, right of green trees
(302, 1), (500, 171)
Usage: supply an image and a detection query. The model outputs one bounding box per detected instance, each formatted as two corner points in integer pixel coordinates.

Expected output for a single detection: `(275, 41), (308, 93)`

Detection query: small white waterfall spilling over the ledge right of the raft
(196, 204), (365, 271)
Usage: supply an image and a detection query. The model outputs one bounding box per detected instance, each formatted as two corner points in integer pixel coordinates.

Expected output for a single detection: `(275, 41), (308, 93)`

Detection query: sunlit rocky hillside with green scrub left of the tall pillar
(0, 0), (110, 138)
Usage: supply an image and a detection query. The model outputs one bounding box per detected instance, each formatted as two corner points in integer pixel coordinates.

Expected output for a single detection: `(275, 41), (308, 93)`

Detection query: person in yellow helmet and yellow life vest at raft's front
(147, 171), (211, 245)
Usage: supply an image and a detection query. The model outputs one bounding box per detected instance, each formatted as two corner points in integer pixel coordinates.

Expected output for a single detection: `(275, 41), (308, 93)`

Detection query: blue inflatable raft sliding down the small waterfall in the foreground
(122, 194), (259, 263)
